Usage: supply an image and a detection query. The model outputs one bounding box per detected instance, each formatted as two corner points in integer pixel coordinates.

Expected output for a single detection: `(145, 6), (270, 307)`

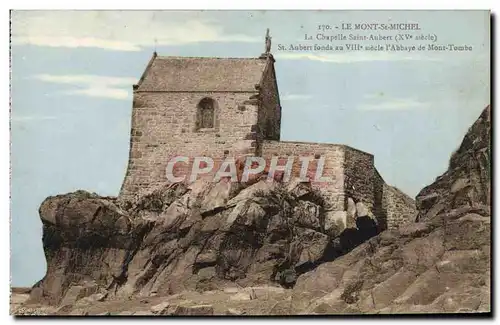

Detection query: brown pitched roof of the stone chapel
(136, 53), (270, 92)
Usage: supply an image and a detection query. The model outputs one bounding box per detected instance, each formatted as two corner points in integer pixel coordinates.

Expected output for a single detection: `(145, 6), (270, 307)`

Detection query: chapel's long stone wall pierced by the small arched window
(120, 91), (258, 196)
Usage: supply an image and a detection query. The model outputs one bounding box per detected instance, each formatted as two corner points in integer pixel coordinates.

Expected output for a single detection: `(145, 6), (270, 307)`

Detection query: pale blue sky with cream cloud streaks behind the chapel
(11, 11), (490, 286)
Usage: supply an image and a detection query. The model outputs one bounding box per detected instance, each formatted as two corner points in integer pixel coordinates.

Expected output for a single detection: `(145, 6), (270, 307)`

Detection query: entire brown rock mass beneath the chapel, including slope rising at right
(22, 107), (491, 315)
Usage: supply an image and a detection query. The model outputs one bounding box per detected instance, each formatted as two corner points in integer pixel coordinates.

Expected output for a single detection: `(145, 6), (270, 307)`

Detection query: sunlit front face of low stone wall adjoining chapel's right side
(262, 140), (345, 211)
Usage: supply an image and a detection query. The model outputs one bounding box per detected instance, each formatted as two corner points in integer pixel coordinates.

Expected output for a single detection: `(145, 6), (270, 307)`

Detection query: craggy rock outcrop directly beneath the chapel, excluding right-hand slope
(31, 175), (377, 306)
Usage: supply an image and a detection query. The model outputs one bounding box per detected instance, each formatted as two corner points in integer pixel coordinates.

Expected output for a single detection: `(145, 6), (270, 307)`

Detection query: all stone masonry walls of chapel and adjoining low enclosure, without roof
(120, 86), (415, 229)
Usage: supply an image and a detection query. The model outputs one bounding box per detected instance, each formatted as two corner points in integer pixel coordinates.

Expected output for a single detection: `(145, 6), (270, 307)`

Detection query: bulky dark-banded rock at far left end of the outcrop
(33, 191), (151, 304)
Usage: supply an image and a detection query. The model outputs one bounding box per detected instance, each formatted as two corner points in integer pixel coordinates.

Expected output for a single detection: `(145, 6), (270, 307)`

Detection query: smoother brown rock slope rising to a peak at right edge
(292, 107), (491, 314)
